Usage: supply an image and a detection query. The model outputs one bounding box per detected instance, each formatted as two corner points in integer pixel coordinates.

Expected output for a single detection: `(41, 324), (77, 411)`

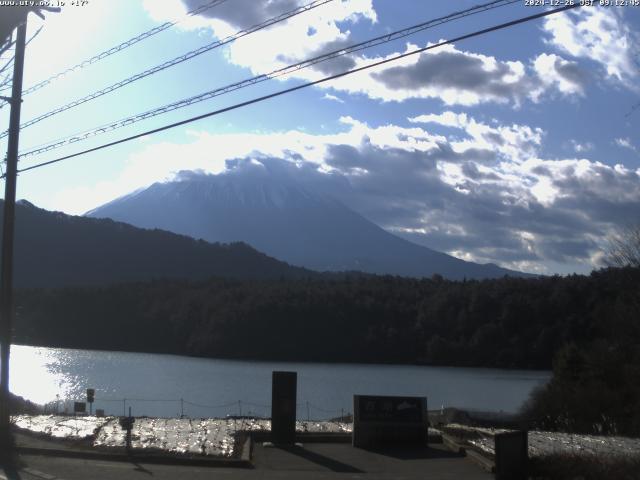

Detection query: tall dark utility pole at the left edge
(0, 13), (27, 448)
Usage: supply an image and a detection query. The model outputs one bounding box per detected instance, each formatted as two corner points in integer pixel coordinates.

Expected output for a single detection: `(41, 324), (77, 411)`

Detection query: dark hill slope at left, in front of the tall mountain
(0, 200), (312, 287)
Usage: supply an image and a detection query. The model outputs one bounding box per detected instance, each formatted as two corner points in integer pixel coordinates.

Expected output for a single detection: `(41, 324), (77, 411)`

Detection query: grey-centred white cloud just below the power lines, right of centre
(288, 40), (587, 106)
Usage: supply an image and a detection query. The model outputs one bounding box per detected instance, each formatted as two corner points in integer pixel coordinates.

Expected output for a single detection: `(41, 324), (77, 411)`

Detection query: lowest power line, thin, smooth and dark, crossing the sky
(6, 3), (581, 178)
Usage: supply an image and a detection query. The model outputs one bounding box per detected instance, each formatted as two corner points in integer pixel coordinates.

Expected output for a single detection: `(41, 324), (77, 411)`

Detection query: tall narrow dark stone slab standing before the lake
(271, 372), (298, 445)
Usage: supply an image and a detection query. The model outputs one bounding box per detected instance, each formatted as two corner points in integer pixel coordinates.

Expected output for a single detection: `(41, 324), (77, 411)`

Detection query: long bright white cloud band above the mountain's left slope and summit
(52, 117), (444, 214)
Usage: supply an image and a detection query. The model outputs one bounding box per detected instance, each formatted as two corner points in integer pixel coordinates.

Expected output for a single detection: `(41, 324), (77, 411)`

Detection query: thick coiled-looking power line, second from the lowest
(17, 0), (520, 158)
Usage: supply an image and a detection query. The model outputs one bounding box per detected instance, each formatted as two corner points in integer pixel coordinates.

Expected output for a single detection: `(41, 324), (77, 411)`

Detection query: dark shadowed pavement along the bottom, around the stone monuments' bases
(0, 443), (493, 480)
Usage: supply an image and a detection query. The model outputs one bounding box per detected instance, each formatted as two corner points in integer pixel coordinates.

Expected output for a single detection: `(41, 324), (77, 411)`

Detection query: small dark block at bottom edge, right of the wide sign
(495, 431), (529, 480)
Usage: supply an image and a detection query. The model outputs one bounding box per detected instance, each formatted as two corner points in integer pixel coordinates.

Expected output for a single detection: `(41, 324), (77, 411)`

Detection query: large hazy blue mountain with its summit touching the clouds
(87, 167), (523, 279)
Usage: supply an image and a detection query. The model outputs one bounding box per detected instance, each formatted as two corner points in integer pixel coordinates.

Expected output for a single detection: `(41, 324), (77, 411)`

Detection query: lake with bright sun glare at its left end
(10, 345), (551, 419)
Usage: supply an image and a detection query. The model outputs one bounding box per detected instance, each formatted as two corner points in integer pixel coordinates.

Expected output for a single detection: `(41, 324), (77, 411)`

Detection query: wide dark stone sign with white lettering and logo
(353, 395), (428, 448)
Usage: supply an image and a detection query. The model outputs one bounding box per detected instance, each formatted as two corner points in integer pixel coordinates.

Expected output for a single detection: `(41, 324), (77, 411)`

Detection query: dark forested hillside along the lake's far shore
(15, 268), (640, 369)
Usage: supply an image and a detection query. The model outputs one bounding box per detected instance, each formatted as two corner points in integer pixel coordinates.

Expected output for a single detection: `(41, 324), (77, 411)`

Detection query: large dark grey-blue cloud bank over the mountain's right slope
(191, 121), (640, 269)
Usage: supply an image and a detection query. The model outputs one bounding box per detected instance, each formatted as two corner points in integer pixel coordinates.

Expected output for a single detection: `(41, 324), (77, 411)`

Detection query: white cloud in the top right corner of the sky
(544, 7), (638, 90)
